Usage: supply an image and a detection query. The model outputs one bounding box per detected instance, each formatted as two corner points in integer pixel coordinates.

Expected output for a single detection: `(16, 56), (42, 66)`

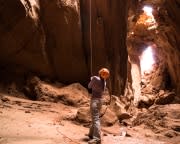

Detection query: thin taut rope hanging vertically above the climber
(89, 0), (93, 76)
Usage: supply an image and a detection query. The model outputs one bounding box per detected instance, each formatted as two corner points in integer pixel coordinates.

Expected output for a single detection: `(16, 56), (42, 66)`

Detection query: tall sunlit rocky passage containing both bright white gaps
(127, 1), (177, 107)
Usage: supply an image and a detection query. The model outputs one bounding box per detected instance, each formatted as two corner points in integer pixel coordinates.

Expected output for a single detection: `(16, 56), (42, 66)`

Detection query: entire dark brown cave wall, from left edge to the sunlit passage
(0, 0), (128, 95)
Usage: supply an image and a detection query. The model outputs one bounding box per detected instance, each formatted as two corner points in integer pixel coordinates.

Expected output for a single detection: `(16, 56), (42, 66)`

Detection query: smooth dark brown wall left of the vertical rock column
(0, 0), (87, 83)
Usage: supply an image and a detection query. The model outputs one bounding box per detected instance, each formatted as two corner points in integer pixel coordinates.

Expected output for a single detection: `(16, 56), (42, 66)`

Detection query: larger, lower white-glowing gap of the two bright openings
(140, 46), (155, 75)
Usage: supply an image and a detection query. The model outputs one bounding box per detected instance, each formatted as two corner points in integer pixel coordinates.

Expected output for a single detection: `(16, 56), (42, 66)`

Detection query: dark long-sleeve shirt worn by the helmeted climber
(88, 76), (106, 98)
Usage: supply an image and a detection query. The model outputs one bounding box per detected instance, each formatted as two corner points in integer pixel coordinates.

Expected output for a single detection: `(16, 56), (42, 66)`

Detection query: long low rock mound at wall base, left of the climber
(25, 76), (89, 106)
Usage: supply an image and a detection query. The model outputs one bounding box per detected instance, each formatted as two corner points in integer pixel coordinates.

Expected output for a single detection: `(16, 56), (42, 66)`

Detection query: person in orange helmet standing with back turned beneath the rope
(88, 68), (110, 144)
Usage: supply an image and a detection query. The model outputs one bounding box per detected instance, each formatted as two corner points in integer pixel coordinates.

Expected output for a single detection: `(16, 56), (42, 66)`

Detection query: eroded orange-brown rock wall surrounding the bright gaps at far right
(127, 0), (180, 100)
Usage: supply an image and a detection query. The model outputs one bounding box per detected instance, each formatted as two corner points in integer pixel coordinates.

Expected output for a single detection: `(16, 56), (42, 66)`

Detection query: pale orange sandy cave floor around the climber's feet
(0, 96), (177, 144)
